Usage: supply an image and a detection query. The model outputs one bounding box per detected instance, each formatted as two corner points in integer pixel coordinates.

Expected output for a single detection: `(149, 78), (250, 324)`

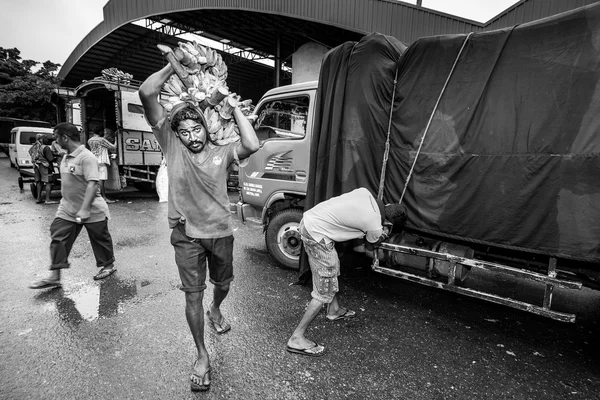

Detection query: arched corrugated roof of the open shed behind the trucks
(59, 0), (593, 99)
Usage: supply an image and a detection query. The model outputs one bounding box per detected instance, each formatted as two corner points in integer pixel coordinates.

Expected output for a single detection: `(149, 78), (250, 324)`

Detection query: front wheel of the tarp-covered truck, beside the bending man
(265, 208), (302, 270)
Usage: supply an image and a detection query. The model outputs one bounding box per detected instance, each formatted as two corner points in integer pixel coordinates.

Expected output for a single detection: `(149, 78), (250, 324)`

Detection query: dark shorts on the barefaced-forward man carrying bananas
(171, 223), (233, 292)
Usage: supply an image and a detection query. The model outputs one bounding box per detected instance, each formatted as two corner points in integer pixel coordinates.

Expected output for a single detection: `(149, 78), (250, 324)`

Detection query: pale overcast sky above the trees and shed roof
(0, 0), (517, 68)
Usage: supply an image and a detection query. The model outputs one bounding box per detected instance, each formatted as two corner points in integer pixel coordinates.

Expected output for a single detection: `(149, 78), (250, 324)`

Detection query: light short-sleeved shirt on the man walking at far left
(56, 145), (110, 222)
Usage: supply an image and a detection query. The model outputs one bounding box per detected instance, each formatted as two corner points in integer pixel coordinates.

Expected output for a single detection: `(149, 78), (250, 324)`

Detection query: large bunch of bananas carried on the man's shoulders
(157, 41), (253, 144)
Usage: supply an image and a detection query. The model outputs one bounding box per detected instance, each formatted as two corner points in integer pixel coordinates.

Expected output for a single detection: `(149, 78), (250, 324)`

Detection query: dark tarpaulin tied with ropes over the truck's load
(308, 5), (600, 270)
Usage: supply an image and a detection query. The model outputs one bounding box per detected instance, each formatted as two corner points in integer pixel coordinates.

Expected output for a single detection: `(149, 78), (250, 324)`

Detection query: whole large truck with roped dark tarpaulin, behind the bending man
(238, 4), (600, 322)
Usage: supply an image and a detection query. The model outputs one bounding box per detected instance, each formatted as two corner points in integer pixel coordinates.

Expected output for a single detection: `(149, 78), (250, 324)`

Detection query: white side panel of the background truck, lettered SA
(119, 91), (162, 166)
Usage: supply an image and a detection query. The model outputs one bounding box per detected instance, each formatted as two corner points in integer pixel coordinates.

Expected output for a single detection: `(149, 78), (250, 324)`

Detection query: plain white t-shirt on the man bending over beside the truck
(302, 188), (383, 243)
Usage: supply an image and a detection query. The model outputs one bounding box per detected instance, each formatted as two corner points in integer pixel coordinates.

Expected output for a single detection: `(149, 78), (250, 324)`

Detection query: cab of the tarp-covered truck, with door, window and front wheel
(237, 81), (318, 269)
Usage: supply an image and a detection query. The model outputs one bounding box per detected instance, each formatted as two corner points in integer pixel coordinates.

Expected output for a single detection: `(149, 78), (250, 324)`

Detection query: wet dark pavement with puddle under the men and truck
(0, 155), (600, 400)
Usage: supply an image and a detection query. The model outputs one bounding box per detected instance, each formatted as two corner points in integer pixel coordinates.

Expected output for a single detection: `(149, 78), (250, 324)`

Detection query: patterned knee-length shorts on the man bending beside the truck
(298, 222), (340, 304)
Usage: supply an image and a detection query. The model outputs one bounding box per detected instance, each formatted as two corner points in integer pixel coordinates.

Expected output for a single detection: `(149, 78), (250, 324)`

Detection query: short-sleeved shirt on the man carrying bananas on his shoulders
(152, 118), (238, 239)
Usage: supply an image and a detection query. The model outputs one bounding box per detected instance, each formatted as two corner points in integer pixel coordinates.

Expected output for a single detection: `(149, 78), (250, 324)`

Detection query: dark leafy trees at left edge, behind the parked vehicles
(0, 47), (60, 124)
